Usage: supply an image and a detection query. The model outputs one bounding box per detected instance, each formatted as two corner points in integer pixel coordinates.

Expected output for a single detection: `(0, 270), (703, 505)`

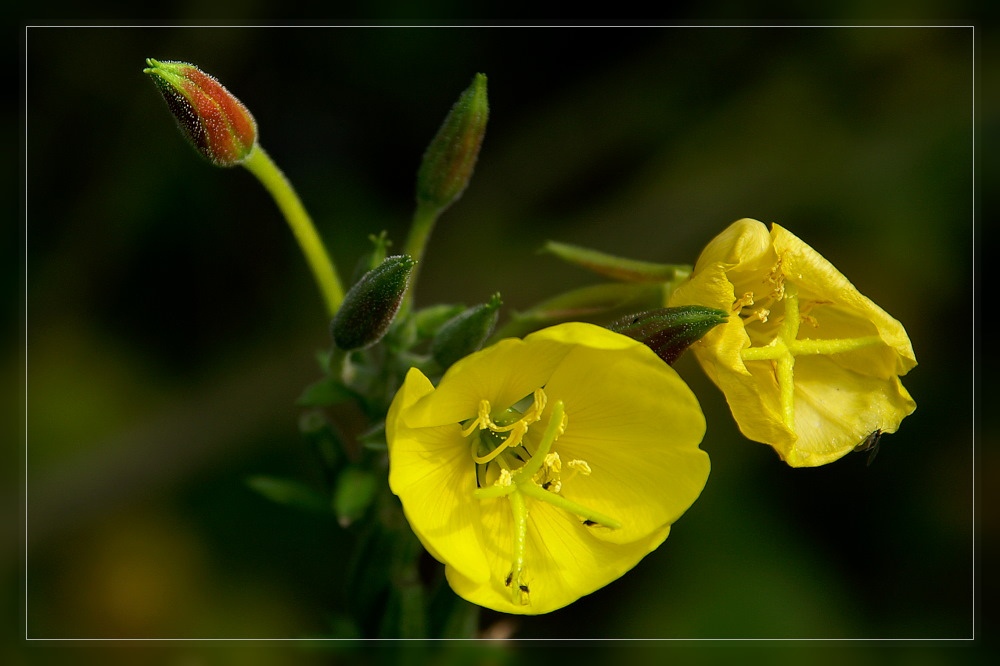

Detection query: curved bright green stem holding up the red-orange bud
(243, 145), (344, 317)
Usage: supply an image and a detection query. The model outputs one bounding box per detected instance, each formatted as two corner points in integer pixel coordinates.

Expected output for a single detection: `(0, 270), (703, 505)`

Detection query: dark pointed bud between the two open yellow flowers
(608, 305), (728, 365)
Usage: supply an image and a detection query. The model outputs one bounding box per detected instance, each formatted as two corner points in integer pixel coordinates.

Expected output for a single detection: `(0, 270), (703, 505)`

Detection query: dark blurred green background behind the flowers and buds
(15, 18), (984, 664)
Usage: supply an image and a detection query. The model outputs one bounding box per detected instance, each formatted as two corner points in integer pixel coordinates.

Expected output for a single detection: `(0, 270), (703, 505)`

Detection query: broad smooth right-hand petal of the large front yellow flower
(532, 344), (709, 543)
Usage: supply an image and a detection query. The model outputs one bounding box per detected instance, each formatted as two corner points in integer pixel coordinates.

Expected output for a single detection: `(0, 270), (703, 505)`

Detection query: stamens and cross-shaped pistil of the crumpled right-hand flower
(734, 274), (882, 432)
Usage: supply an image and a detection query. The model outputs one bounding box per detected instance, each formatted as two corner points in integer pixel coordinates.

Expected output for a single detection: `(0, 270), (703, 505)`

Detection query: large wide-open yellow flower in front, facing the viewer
(386, 323), (709, 614)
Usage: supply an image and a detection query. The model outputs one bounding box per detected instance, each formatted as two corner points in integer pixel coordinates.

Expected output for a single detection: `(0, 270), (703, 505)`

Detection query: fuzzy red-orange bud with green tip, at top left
(142, 58), (257, 166)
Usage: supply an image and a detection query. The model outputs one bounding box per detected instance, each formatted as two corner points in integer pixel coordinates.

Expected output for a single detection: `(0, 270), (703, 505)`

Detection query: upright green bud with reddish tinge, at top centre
(417, 74), (490, 212)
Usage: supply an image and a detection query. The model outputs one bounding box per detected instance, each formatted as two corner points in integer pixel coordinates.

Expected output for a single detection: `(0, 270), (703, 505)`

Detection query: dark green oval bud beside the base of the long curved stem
(330, 254), (417, 351)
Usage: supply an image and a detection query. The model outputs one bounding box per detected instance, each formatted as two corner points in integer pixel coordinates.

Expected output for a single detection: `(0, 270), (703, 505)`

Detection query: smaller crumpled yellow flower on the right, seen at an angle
(669, 219), (917, 467)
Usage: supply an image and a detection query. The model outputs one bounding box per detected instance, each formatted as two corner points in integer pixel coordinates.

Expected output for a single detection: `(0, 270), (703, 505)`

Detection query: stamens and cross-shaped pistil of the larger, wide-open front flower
(462, 388), (621, 605)
